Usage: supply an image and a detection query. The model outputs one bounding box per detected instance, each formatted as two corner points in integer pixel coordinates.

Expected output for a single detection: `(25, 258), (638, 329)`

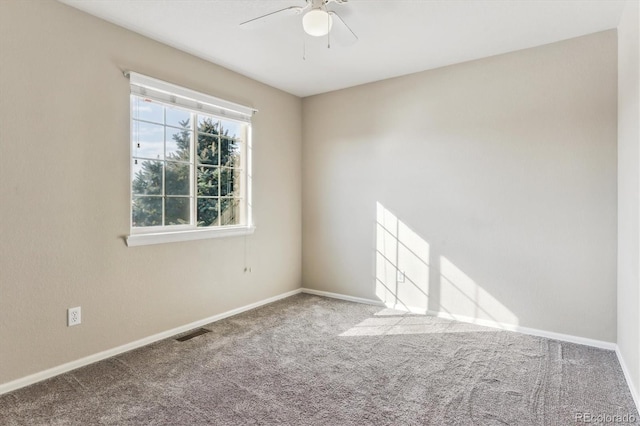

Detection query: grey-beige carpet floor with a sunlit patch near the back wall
(0, 294), (640, 426)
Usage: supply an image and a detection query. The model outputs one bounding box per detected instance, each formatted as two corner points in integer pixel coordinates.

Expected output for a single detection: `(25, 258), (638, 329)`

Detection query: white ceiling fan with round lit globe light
(240, 0), (358, 47)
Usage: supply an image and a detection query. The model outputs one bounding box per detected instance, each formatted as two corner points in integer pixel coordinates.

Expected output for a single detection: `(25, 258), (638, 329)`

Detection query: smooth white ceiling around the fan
(60, 0), (624, 97)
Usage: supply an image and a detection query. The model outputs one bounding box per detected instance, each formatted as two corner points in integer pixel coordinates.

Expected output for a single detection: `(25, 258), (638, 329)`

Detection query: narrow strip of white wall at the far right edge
(618, 1), (640, 402)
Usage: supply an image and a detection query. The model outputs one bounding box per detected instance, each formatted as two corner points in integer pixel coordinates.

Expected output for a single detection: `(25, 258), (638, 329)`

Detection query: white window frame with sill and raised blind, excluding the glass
(125, 72), (257, 247)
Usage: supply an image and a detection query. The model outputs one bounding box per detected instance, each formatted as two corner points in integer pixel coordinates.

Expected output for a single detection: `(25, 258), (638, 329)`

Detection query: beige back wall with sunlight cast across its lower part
(302, 30), (617, 342)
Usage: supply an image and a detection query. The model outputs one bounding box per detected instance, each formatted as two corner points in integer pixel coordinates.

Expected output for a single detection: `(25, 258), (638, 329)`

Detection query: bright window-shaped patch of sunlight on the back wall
(375, 203), (518, 329)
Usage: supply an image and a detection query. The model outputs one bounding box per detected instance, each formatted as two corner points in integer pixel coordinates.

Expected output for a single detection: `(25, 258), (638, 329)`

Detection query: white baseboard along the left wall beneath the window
(0, 289), (302, 395)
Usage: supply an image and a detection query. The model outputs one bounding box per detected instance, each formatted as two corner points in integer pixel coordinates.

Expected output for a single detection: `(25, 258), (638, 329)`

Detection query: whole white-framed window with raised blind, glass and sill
(127, 73), (254, 246)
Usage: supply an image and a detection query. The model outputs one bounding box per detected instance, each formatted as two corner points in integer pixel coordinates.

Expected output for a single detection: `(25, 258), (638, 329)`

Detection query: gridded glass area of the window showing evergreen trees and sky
(130, 85), (250, 232)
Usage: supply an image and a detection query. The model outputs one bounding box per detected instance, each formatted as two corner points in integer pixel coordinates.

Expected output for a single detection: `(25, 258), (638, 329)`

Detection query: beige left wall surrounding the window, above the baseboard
(0, 0), (301, 384)
